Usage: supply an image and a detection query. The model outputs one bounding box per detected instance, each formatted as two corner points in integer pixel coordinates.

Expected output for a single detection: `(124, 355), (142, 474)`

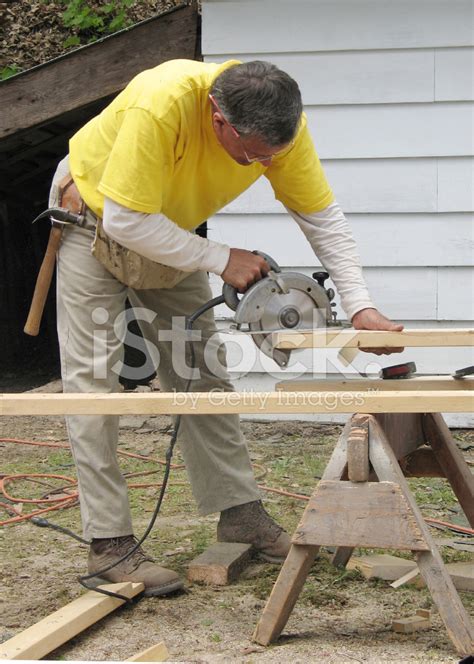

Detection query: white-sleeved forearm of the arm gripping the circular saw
(103, 198), (230, 275)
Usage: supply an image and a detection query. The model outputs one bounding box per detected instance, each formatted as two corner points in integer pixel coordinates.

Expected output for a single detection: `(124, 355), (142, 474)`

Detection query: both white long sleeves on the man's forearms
(103, 198), (375, 320)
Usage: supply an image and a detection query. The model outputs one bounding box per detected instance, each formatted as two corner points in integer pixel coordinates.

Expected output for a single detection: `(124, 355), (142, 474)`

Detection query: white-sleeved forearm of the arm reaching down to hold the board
(287, 202), (375, 320)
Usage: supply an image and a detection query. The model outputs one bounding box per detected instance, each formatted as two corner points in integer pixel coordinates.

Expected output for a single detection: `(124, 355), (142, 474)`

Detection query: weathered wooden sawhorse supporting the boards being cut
(253, 413), (474, 655)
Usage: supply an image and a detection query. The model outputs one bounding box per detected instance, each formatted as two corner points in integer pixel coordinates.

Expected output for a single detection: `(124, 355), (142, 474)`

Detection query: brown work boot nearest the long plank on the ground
(88, 535), (183, 597)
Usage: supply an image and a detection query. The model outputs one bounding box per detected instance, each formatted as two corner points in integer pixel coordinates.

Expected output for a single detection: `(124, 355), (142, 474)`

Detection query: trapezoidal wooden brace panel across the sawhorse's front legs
(292, 480), (429, 551)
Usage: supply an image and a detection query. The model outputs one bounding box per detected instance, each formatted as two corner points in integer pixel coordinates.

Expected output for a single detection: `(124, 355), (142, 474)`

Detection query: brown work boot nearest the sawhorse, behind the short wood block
(217, 500), (291, 563)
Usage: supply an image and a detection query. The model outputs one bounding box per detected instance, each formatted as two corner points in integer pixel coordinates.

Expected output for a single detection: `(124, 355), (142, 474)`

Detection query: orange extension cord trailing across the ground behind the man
(0, 438), (474, 535)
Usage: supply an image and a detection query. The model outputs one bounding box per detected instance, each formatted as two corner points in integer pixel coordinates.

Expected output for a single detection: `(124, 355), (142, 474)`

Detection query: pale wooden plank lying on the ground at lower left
(0, 581), (144, 659)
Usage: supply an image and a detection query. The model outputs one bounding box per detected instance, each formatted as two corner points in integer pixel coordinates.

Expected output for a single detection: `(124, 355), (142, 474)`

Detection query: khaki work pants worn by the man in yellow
(50, 160), (260, 539)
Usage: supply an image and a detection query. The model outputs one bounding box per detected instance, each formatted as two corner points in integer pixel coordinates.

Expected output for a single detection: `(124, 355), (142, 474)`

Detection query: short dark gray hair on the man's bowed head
(211, 60), (303, 147)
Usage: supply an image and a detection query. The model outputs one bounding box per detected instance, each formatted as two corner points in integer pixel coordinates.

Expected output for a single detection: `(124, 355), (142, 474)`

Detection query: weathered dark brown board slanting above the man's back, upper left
(0, 3), (198, 139)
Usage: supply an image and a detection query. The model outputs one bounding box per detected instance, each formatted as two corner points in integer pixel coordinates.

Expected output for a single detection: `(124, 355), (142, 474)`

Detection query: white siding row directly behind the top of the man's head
(205, 47), (474, 106)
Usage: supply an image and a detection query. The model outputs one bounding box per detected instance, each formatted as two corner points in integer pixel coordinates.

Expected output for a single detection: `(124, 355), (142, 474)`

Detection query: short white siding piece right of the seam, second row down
(434, 48), (474, 101)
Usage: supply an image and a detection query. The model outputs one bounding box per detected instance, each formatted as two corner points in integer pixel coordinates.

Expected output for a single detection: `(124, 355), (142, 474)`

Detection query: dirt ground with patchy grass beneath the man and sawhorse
(0, 396), (474, 664)
